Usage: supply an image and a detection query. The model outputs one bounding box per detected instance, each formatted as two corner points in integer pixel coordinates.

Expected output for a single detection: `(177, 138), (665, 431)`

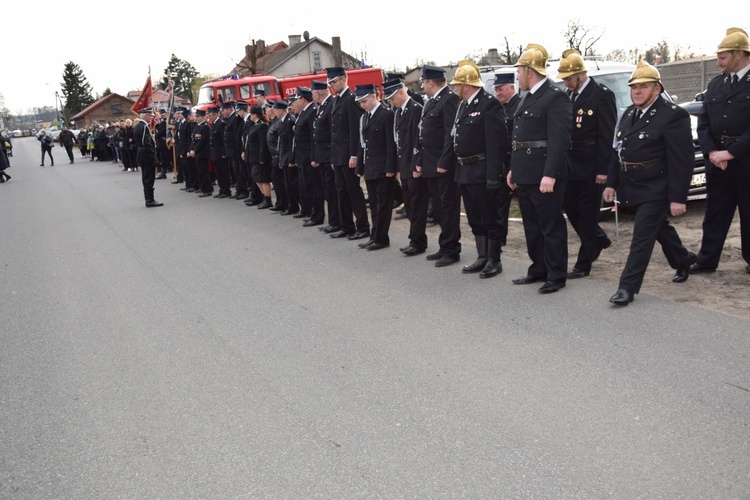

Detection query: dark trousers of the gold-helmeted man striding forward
(618, 200), (689, 293)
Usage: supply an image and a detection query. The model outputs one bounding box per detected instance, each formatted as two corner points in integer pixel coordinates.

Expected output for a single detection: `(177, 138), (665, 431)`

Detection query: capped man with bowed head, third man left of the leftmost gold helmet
(355, 84), (397, 250)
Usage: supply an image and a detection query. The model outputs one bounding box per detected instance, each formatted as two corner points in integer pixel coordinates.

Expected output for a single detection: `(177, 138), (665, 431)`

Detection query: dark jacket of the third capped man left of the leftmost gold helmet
(356, 105), (396, 181)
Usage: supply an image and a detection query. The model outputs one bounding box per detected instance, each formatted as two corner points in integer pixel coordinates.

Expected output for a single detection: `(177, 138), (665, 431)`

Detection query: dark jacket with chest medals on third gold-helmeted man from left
(568, 78), (617, 182)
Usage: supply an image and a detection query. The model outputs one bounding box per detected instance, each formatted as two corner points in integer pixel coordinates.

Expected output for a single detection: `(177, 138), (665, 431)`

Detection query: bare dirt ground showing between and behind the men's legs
(412, 198), (750, 318)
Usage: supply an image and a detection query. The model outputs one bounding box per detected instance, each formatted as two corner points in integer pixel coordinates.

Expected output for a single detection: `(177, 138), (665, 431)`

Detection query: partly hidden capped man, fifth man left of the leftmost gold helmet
(310, 80), (341, 234)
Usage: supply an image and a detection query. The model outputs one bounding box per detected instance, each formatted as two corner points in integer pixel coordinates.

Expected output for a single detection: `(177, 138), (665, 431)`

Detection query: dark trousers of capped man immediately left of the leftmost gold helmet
(427, 172), (461, 257)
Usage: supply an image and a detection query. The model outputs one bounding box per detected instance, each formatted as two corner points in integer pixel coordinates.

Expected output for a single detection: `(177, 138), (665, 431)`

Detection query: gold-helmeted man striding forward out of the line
(604, 61), (696, 306)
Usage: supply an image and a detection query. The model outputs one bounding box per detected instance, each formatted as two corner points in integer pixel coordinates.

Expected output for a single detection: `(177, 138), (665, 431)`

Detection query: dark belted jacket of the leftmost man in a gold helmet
(453, 88), (508, 184)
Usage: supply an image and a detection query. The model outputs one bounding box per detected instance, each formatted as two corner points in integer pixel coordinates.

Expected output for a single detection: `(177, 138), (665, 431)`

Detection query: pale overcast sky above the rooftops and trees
(0, 0), (748, 114)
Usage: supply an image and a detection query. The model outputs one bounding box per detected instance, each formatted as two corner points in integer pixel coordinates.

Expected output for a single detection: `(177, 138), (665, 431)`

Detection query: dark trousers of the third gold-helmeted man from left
(563, 179), (609, 272)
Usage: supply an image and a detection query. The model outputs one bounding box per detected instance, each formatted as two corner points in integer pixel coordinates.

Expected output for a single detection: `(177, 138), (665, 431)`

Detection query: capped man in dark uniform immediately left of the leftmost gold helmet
(413, 66), (461, 267)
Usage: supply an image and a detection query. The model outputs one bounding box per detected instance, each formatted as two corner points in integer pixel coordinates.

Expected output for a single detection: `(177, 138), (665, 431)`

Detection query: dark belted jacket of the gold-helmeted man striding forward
(607, 96), (695, 206)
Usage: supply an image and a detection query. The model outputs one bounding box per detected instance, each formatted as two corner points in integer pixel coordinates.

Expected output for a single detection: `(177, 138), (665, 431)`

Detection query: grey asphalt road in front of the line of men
(0, 139), (750, 499)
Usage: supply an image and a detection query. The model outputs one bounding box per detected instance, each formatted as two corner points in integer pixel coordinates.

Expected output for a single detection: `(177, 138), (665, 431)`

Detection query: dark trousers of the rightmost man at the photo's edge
(698, 173), (750, 268)
